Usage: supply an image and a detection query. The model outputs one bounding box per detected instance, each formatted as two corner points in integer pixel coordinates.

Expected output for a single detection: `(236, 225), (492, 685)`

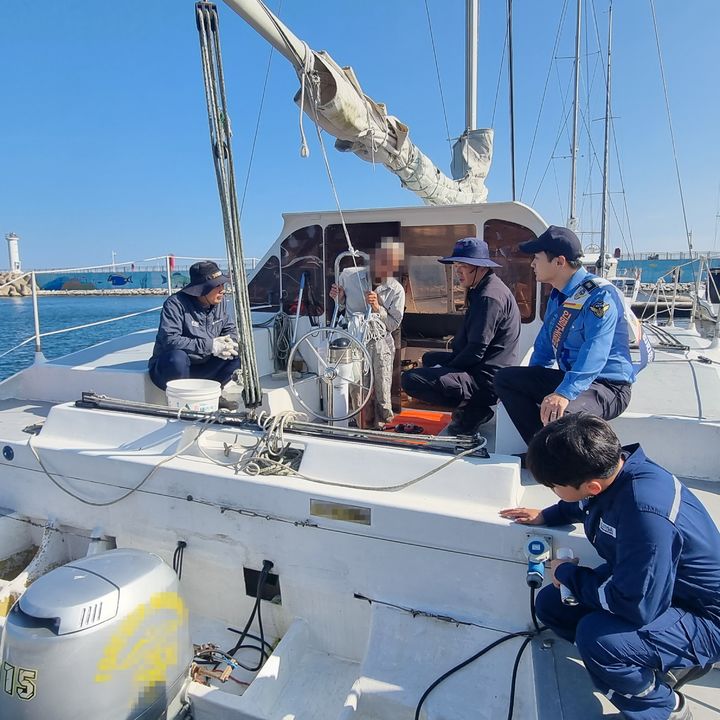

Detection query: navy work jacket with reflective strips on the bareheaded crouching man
(543, 445), (720, 627)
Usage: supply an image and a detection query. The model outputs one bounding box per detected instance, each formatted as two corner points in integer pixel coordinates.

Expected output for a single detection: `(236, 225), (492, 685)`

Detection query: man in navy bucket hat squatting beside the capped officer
(402, 237), (520, 435)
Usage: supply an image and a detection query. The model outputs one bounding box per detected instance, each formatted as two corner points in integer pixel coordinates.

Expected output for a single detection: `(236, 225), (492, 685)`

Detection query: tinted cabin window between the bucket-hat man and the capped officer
(483, 220), (537, 323)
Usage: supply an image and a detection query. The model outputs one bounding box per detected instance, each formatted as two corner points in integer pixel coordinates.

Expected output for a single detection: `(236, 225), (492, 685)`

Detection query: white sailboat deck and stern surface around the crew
(0, 324), (720, 720)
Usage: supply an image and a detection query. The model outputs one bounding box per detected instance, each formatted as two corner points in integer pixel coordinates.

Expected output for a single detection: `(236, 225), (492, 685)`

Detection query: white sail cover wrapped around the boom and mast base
(295, 51), (493, 205)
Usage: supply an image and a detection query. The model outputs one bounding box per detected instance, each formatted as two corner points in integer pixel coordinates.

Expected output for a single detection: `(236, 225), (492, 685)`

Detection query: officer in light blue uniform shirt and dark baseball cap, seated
(495, 225), (635, 443)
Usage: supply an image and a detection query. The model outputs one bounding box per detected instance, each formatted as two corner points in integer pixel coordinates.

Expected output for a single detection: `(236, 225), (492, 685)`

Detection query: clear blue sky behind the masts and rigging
(0, 0), (720, 268)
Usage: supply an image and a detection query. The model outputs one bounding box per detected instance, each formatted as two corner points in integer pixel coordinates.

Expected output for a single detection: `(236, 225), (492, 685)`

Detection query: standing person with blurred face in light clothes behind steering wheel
(330, 237), (405, 429)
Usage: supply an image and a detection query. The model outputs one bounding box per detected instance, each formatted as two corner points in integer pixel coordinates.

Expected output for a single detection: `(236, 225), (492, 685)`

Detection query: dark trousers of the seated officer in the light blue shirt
(495, 366), (631, 443)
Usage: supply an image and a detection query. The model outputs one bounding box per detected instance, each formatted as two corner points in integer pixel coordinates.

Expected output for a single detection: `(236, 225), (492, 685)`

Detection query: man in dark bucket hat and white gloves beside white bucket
(148, 260), (240, 390)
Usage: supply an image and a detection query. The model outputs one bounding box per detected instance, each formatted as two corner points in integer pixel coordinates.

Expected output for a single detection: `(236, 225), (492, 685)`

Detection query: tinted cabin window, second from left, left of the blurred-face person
(280, 225), (325, 317)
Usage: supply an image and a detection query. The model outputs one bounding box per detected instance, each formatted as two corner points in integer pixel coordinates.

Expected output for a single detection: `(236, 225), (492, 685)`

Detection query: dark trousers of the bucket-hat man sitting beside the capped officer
(400, 352), (497, 411)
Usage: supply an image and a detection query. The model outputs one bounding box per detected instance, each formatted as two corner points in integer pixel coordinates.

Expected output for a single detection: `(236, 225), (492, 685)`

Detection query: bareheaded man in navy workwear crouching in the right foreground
(500, 413), (720, 720)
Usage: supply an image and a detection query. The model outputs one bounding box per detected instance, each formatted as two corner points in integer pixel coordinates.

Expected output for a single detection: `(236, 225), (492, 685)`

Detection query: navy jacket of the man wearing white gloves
(148, 290), (237, 367)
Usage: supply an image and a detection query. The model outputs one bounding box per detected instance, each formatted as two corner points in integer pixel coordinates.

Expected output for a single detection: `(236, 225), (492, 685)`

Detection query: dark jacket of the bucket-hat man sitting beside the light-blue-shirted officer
(445, 270), (520, 375)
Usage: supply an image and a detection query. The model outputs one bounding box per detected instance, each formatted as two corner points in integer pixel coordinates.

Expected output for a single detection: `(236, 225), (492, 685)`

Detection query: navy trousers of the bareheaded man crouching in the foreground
(535, 585), (720, 720)
